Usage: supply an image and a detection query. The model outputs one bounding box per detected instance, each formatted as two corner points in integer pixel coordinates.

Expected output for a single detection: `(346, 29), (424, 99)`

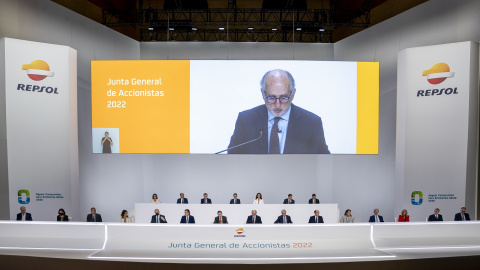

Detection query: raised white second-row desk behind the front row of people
(130, 203), (339, 224)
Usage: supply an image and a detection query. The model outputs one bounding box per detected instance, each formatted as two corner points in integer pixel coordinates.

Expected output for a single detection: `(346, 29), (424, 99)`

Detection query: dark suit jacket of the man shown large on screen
(228, 104), (330, 154)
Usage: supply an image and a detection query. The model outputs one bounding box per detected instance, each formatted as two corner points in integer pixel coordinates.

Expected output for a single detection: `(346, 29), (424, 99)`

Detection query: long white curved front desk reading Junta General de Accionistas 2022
(0, 221), (480, 264)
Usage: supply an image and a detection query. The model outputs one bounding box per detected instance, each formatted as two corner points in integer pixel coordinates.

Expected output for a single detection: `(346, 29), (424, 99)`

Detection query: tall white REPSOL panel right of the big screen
(395, 42), (478, 221)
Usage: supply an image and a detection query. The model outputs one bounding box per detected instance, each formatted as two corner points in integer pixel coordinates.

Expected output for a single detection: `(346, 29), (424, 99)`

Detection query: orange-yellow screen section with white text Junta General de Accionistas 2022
(92, 60), (190, 154)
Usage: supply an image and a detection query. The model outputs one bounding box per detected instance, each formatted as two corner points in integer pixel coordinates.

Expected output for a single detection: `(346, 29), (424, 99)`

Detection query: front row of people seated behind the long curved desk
(16, 206), (470, 224)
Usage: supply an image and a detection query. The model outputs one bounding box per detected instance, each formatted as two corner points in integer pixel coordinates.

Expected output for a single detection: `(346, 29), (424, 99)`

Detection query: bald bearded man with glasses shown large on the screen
(228, 69), (330, 154)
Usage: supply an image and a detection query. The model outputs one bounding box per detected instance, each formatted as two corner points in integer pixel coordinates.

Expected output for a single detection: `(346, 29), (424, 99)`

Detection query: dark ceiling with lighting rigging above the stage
(52, 0), (427, 43)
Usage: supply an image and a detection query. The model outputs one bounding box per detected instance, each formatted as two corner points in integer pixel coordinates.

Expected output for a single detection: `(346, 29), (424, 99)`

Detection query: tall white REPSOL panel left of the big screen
(0, 38), (78, 220)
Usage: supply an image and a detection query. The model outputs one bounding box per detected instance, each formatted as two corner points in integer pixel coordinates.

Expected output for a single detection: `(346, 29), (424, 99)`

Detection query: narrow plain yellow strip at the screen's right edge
(357, 62), (379, 154)
